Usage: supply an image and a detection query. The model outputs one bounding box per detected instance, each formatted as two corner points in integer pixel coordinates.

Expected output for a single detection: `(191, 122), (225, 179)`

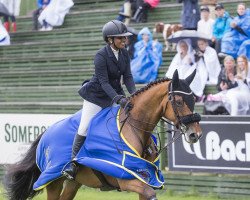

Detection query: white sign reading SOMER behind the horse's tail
(0, 114), (68, 164)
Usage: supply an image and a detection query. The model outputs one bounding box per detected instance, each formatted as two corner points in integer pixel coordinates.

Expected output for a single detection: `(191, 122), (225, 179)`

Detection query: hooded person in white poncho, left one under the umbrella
(166, 39), (205, 101)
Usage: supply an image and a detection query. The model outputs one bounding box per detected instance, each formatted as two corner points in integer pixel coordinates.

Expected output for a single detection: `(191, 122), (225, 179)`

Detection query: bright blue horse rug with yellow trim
(33, 107), (164, 190)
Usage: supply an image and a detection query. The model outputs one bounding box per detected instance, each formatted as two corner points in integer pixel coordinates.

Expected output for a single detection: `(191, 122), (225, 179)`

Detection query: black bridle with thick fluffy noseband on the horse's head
(164, 82), (201, 133)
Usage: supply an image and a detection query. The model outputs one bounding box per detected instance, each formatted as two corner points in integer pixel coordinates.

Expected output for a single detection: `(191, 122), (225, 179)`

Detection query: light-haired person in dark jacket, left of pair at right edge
(217, 56), (238, 91)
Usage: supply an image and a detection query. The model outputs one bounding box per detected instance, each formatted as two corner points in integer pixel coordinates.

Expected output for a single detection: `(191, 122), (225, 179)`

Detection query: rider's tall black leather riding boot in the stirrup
(62, 134), (86, 180)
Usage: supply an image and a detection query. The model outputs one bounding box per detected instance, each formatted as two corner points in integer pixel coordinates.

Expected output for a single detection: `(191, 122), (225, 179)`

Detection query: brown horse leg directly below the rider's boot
(59, 180), (81, 200)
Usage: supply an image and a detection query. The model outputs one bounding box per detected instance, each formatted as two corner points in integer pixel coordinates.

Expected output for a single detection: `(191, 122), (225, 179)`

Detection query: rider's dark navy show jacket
(78, 45), (135, 108)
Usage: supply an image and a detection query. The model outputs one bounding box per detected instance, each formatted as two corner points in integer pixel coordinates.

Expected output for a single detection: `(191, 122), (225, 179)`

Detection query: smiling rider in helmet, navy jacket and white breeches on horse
(63, 20), (135, 180)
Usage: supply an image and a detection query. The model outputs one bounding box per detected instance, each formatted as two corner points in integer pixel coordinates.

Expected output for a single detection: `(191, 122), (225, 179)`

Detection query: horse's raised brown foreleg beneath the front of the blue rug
(118, 179), (157, 200)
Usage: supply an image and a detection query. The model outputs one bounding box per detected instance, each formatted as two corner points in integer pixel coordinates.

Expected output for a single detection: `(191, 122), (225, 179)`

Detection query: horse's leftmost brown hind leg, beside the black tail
(46, 178), (64, 200)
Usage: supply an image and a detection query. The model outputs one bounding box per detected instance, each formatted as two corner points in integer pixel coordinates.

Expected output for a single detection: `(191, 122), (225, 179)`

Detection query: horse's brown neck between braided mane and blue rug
(121, 82), (167, 155)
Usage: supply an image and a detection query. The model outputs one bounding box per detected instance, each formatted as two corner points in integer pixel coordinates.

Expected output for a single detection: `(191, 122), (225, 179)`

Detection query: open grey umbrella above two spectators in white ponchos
(167, 30), (211, 43)
